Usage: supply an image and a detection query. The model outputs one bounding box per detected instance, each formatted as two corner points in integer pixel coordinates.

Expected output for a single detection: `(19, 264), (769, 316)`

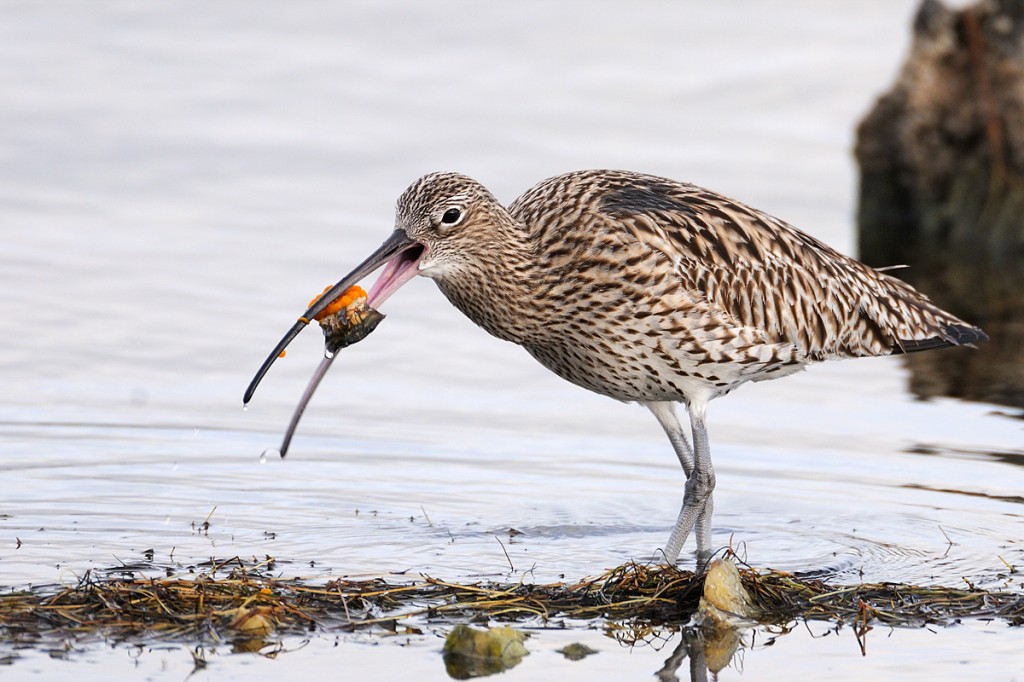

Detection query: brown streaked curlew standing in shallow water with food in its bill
(245, 170), (987, 565)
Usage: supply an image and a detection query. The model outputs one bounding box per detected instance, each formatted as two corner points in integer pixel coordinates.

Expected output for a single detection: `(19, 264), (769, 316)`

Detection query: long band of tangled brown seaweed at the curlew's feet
(0, 557), (1024, 648)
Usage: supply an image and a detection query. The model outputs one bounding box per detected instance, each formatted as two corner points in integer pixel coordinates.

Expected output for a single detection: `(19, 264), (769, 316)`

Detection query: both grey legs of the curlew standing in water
(647, 401), (715, 569)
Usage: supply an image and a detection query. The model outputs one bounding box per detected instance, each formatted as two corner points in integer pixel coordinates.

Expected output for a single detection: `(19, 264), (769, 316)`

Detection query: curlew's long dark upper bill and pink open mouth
(243, 229), (426, 403)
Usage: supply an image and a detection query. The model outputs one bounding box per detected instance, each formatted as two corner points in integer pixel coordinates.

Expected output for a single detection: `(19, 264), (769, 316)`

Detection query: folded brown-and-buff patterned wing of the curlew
(585, 176), (984, 359)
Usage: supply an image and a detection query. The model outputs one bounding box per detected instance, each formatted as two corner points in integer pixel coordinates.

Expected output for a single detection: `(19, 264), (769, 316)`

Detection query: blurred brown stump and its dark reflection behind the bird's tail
(856, 0), (1024, 407)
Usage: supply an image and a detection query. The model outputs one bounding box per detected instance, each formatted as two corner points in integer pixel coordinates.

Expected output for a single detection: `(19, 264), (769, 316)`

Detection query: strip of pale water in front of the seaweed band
(12, 622), (1024, 682)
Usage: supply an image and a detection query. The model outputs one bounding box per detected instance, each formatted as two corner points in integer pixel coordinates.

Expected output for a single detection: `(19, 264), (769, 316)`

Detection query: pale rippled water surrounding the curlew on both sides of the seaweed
(0, 2), (1024, 679)
